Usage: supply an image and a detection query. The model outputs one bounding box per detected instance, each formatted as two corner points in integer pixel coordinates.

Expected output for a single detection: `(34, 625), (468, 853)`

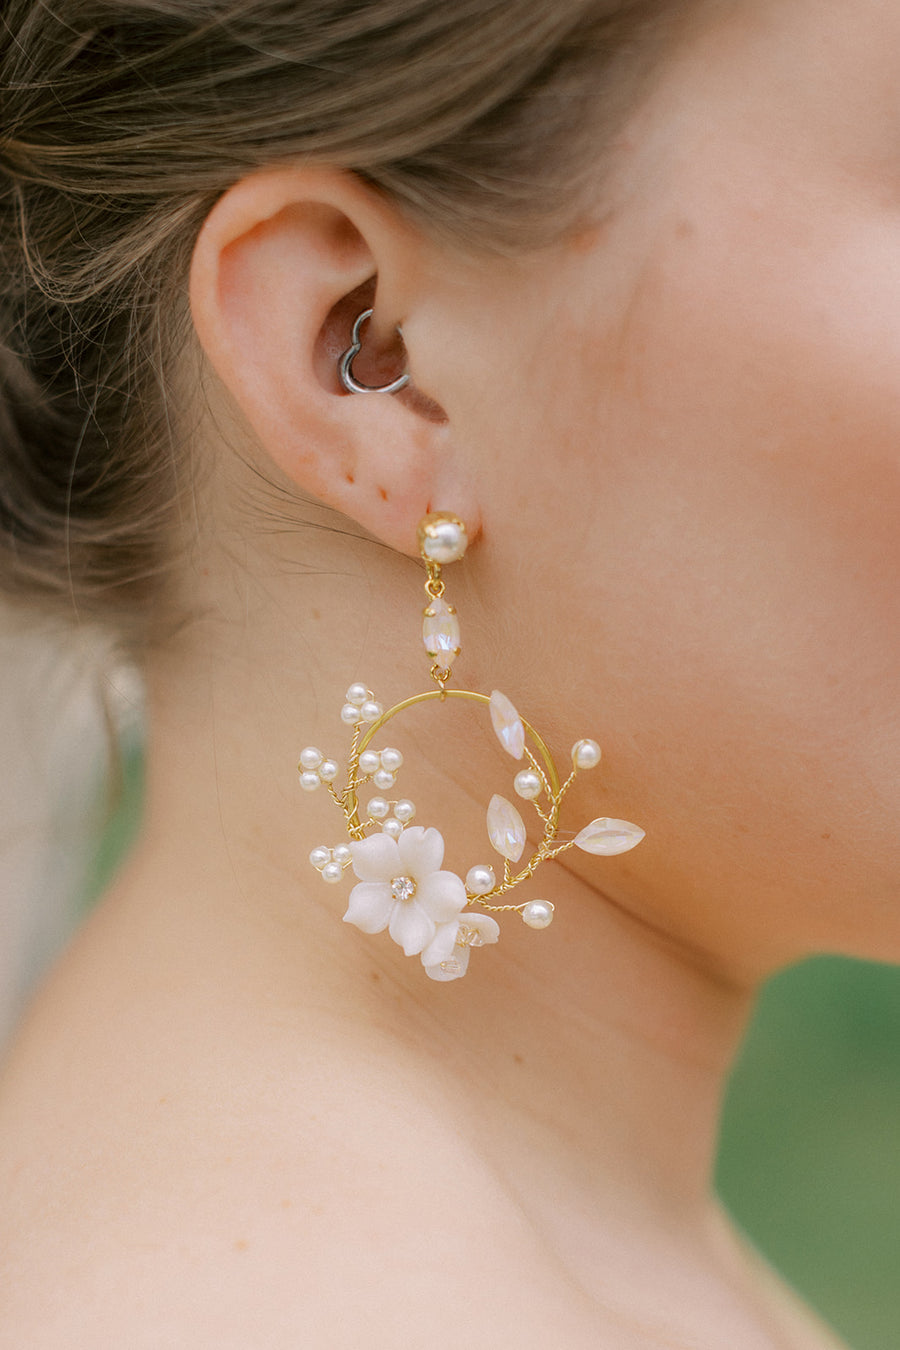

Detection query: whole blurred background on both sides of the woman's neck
(0, 624), (900, 1350)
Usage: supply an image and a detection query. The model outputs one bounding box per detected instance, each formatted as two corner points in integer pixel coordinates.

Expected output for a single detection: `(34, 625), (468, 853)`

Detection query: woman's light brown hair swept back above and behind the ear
(0, 0), (673, 631)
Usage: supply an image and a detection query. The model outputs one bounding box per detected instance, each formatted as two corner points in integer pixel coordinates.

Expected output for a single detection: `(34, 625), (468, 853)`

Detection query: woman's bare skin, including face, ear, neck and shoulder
(0, 0), (900, 1350)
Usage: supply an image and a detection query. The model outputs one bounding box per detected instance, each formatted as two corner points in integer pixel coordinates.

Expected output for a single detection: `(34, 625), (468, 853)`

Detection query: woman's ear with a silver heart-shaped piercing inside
(190, 166), (478, 552)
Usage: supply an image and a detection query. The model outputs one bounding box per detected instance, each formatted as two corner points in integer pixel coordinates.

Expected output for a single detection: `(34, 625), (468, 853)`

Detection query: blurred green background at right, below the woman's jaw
(716, 957), (900, 1350)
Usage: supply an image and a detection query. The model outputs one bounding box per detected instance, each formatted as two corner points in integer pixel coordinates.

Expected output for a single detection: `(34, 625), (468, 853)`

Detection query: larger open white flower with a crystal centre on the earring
(344, 825), (468, 956)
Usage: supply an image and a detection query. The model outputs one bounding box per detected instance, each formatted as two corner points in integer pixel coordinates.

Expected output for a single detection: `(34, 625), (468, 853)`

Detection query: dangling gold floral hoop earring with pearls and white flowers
(300, 512), (644, 980)
